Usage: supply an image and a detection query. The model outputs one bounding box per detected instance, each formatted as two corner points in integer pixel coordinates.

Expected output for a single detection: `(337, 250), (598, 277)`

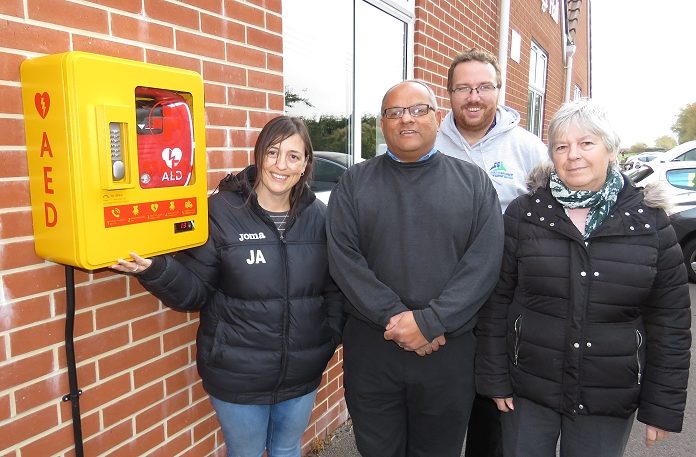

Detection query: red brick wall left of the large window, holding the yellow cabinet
(0, 0), (346, 457)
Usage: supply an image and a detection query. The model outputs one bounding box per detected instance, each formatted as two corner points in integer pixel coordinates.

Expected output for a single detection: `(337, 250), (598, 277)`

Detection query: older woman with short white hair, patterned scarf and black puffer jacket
(476, 100), (691, 457)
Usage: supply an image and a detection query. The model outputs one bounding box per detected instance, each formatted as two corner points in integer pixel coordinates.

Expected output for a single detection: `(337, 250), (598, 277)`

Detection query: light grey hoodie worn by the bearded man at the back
(435, 105), (549, 212)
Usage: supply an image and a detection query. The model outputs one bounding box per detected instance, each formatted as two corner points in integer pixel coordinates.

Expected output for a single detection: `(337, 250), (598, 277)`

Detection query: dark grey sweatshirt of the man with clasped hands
(326, 153), (503, 341)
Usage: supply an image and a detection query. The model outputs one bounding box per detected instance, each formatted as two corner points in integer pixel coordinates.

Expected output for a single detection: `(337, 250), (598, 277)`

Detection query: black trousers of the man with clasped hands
(343, 317), (476, 457)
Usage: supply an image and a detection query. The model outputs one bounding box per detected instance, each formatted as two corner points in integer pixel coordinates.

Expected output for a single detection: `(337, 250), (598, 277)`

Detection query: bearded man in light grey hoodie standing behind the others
(435, 49), (548, 457)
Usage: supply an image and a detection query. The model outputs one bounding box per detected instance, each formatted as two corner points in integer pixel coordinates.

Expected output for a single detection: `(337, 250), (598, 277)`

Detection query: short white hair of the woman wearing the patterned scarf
(549, 98), (621, 158)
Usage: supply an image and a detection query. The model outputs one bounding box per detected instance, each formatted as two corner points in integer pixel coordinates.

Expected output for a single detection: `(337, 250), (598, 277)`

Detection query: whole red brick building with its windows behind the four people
(0, 0), (591, 457)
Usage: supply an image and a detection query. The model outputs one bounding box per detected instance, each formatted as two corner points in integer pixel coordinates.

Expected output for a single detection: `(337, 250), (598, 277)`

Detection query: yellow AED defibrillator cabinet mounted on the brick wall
(20, 51), (208, 269)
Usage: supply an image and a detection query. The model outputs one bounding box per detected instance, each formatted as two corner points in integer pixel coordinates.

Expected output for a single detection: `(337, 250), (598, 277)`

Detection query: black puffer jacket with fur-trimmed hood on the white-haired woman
(476, 167), (691, 432)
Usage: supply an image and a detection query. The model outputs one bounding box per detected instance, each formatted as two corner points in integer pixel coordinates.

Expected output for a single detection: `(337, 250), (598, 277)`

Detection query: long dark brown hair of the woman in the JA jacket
(254, 116), (314, 214)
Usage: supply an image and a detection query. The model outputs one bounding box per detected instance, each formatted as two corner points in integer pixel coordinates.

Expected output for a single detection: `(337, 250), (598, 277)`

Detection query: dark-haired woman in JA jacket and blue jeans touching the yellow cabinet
(112, 116), (344, 457)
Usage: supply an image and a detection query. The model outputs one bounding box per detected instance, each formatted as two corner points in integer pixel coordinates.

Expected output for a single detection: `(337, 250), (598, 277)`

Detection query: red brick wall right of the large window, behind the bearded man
(414, 0), (589, 139)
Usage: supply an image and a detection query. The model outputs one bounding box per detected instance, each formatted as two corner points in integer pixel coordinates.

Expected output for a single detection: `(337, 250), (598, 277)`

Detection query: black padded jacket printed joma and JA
(138, 166), (344, 404)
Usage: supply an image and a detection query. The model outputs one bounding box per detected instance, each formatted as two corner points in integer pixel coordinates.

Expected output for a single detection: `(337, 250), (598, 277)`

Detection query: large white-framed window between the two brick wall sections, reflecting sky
(283, 0), (414, 163)
